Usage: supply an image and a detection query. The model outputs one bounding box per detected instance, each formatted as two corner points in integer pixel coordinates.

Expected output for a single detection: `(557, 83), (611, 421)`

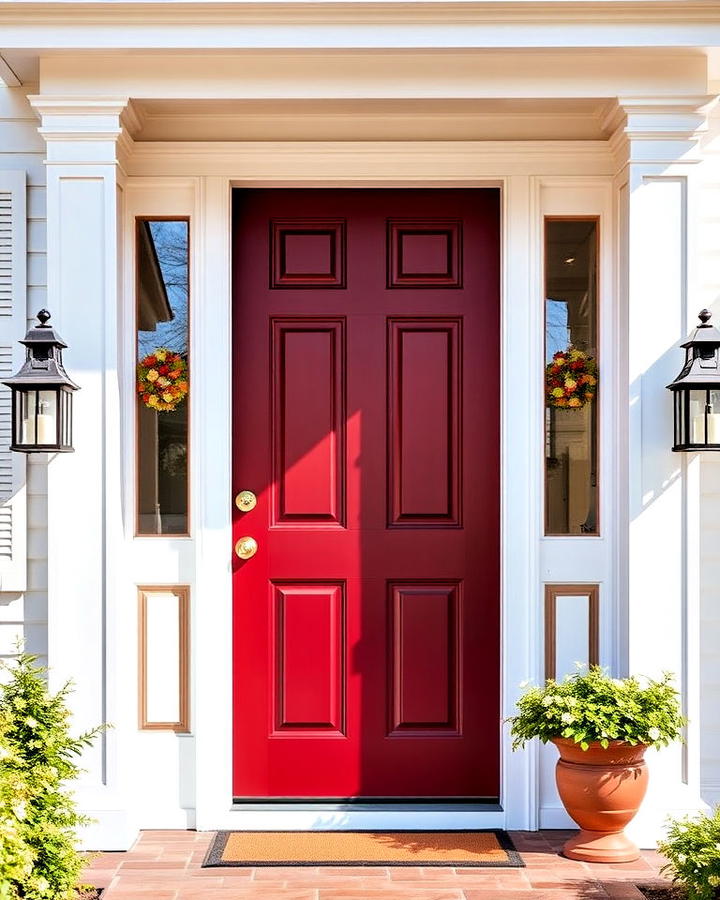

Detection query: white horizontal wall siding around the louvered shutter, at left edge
(0, 85), (47, 658)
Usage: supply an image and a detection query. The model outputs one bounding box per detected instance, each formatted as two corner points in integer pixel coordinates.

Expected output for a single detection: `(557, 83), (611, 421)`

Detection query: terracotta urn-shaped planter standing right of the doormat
(553, 738), (648, 863)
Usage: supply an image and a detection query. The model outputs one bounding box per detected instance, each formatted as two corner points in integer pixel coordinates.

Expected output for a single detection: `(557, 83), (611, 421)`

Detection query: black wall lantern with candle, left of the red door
(3, 309), (78, 453)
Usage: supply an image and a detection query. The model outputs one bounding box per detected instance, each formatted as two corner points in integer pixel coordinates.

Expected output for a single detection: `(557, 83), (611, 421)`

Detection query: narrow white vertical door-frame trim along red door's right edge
(500, 176), (542, 830)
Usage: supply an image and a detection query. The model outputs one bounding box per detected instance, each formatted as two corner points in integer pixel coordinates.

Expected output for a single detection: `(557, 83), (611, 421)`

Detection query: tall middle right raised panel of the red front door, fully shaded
(388, 319), (462, 528)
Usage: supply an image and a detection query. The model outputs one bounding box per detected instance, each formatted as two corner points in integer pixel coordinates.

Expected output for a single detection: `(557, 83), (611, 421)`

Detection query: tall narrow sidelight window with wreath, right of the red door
(545, 218), (600, 535)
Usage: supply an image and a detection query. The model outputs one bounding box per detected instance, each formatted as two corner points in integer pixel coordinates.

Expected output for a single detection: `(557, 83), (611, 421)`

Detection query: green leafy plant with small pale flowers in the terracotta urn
(509, 666), (685, 750)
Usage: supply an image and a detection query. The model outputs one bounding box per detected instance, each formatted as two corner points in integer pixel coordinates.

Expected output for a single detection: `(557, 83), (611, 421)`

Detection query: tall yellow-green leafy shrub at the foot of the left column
(0, 653), (101, 900)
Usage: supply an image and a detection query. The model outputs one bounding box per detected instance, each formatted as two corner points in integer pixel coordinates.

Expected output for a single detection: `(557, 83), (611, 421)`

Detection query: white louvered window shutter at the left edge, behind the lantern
(0, 171), (27, 591)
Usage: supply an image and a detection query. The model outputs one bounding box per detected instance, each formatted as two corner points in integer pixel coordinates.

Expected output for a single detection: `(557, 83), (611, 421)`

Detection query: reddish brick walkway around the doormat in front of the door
(84, 831), (662, 900)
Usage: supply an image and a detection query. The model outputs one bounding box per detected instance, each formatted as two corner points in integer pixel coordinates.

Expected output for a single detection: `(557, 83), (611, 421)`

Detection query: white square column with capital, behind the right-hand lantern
(612, 97), (712, 846)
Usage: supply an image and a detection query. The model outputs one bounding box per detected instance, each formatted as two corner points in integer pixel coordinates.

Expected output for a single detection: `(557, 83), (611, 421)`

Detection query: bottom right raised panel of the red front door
(388, 582), (462, 736)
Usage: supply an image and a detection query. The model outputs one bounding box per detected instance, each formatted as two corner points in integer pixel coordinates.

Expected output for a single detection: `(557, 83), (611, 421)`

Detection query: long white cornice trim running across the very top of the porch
(0, 0), (720, 53)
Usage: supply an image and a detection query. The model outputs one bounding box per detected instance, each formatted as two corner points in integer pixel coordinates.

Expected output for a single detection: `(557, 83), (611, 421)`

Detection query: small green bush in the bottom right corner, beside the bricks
(658, 807), (720, 900)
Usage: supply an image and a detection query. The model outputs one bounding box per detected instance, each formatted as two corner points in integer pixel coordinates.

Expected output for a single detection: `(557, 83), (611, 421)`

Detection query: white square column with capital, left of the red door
(30, 95), (137, 850)
